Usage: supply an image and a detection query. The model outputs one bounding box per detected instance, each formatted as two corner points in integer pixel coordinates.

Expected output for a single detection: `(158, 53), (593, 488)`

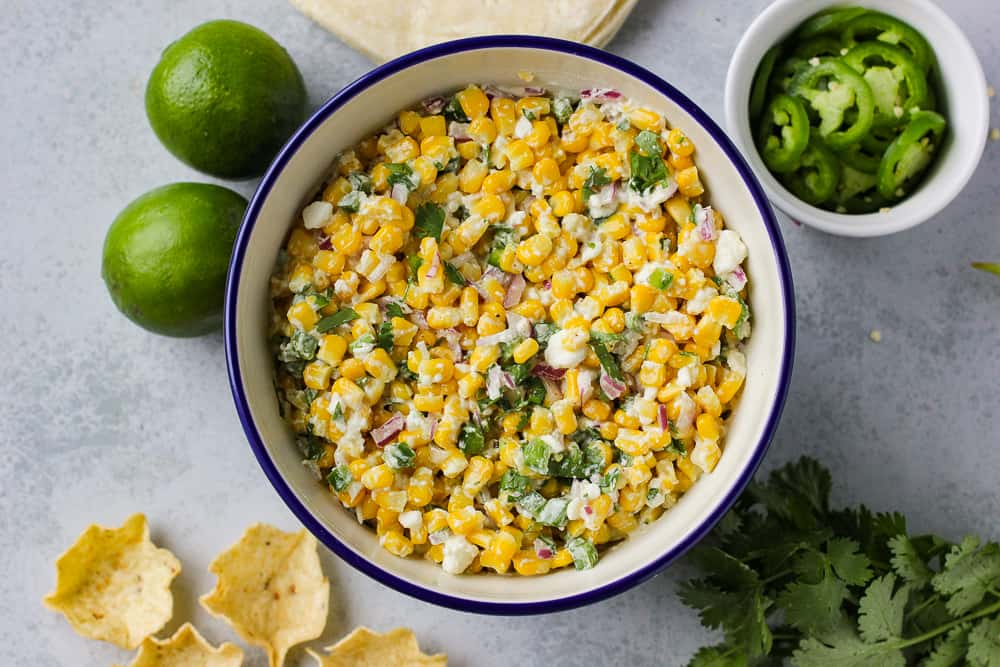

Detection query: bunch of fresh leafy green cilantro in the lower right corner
(680, 458), (1000, 667)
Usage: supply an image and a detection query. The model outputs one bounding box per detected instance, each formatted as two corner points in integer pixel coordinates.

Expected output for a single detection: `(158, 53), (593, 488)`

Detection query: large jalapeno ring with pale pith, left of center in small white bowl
(789, 58), (875, 150)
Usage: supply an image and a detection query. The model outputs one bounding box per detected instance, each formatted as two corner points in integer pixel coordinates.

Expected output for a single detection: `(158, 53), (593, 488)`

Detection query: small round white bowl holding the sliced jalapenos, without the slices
(725, 0), (989, 237)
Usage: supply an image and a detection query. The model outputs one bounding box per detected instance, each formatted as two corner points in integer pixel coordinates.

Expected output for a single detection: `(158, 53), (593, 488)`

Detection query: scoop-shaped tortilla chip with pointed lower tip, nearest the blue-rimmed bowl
(201, 523), (330, 667)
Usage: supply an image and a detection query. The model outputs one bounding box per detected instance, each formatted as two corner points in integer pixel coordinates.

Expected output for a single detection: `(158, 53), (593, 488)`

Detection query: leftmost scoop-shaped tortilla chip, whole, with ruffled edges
(44, 514), (181, 649)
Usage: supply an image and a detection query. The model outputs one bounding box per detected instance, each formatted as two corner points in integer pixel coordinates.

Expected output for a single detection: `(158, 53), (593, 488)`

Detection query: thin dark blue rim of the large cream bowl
(224, 35), (795, 615)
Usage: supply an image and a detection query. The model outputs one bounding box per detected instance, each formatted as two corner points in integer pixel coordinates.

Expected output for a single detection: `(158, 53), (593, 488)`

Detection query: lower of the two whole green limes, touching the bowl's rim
(101, 183), (247, 336)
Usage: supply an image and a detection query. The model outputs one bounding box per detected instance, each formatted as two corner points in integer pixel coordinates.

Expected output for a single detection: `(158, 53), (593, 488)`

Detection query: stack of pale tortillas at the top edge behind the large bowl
(291, 0), (638, 62)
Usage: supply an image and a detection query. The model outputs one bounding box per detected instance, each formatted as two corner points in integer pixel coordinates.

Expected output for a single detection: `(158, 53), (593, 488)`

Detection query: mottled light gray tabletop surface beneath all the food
(0, 0), (1000, 667)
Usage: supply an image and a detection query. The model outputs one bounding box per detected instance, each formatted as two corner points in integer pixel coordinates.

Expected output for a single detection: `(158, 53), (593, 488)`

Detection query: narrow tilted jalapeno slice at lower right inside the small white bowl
(878, 111), (947, 199)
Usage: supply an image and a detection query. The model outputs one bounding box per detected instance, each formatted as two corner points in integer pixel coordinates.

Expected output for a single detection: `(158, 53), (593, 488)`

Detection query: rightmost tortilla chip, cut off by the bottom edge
(309, 628), (448, 667)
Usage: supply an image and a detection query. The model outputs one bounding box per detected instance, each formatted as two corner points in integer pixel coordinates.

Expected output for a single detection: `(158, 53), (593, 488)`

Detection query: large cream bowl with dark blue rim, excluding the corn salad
(225, 36), (795, 614)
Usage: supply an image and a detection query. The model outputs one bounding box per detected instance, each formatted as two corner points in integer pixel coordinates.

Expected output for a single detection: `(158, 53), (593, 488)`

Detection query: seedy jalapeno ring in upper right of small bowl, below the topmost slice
(843, 42), (927, 127)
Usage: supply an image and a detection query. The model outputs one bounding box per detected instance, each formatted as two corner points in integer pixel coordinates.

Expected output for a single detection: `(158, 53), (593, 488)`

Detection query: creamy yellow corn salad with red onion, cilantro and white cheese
(271, 85), (750, 575)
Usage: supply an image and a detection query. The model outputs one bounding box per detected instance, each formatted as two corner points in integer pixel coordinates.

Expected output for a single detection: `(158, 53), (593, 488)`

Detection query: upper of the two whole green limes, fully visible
(146, 21), (306, 178)
